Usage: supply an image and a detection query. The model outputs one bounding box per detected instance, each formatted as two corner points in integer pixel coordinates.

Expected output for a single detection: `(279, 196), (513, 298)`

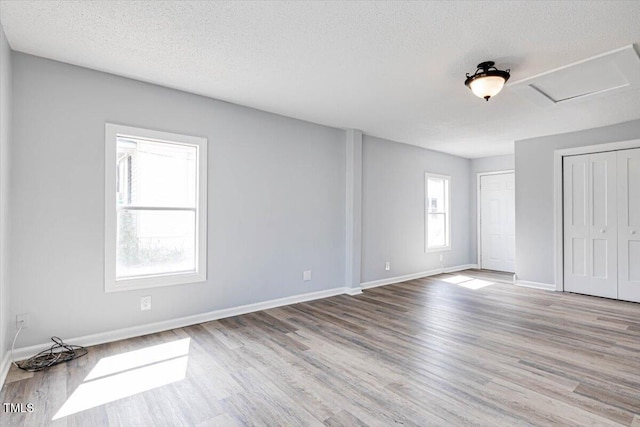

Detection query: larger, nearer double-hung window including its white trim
(105, 124), (207, 292)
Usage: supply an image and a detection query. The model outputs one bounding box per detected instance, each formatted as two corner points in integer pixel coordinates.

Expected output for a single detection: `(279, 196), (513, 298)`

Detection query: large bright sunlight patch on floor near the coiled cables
(52, 338), (191, 420)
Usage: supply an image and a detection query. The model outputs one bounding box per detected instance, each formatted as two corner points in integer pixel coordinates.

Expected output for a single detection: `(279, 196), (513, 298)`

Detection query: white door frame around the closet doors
(553, 139), (640, 292)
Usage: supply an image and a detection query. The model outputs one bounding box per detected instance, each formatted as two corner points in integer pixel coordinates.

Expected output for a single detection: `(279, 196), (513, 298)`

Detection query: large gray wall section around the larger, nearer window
(8, 53), (346, 347)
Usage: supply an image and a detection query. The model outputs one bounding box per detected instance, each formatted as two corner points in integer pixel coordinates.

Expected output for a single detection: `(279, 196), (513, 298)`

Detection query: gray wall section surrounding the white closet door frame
(515, 120), (640, 284)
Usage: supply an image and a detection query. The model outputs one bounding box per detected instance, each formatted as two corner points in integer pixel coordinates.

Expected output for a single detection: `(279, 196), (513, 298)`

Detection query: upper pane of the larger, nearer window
(116, 138), (197, 207)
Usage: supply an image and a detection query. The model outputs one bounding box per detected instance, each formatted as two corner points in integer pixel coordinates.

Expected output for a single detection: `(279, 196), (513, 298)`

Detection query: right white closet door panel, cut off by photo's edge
(617, 148), (640, 302)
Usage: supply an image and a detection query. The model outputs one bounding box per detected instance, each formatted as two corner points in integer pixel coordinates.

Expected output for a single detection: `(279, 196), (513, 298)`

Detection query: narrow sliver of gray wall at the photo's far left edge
(0, 25), (14, 361)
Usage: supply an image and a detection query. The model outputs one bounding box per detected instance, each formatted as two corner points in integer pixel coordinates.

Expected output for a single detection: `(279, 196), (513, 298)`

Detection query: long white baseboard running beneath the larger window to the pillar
(8, 287), (362, 364)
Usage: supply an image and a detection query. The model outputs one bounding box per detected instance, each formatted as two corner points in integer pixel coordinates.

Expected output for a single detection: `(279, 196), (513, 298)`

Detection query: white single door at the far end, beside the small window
(480, 172), (516, 273)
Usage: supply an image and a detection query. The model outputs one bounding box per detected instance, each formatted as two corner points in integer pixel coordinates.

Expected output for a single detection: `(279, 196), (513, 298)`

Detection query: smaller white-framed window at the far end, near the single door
(425, 173), (451, 252)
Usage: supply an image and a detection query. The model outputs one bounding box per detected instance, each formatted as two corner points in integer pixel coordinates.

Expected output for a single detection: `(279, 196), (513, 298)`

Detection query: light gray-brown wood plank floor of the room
(0, 271), (640, 426)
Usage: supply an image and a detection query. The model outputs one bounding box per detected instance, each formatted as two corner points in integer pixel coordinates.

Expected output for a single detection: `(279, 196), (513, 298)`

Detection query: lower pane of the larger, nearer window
(116, 209), (196, 279)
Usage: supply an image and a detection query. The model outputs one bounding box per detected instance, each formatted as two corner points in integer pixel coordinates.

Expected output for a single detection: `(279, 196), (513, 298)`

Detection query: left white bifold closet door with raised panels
(563, 152), (618, 298)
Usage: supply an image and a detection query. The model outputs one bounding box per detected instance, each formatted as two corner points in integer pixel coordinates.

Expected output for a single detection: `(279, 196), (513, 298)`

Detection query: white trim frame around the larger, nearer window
(104, 123), (207, 292)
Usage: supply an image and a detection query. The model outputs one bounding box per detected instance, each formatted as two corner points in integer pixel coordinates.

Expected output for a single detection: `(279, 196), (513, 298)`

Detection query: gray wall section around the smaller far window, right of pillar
(362, 135), (475, 282)
